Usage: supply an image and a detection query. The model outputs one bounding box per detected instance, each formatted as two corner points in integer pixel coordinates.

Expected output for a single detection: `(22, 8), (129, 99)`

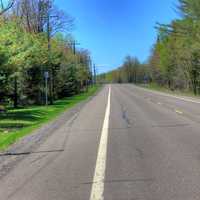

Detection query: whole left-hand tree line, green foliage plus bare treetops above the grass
(0, 0), (92, 107)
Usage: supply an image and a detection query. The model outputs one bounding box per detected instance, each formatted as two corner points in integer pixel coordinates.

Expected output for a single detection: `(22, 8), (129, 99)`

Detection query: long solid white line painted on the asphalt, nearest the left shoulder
(90, 86), (111, 200)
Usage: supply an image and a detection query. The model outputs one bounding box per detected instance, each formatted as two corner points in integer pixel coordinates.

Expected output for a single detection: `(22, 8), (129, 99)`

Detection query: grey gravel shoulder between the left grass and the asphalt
(0, 89), (102, 179)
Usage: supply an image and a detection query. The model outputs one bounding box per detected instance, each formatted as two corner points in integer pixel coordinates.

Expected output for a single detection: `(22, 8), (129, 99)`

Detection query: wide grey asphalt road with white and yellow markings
(0, 85), (200, 200)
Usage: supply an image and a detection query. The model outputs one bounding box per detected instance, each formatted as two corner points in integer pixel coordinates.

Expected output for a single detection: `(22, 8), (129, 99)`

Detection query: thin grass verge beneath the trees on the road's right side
(140, 83), (200, 98)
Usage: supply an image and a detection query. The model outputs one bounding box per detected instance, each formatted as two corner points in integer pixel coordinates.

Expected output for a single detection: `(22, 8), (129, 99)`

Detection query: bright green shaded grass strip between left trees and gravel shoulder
(0, 86), (99, 150)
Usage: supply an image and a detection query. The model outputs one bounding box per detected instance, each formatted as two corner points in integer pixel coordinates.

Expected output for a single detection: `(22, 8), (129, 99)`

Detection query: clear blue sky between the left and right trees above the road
(56, 0), (177, 72)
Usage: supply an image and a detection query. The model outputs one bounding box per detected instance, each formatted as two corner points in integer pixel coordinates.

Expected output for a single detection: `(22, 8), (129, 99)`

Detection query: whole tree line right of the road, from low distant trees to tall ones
(101, 0), (200, 94)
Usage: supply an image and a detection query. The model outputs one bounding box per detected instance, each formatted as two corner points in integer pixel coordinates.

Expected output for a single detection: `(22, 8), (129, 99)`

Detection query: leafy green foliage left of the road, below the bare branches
(0, 19), (91, 106)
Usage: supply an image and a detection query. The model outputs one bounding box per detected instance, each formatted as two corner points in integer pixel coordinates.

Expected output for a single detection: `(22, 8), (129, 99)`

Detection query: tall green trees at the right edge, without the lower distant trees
(149, 0), (200, 94)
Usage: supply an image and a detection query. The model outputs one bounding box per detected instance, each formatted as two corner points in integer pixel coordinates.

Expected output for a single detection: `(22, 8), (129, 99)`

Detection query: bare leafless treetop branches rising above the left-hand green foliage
(11, 0), (74, 36)
